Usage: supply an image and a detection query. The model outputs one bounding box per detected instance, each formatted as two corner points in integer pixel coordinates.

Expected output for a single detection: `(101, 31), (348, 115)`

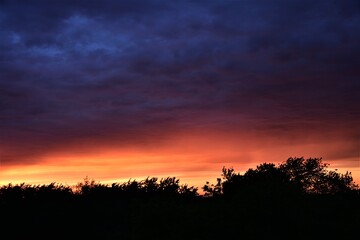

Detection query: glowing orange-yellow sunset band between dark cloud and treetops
(0, 132), (360, 189)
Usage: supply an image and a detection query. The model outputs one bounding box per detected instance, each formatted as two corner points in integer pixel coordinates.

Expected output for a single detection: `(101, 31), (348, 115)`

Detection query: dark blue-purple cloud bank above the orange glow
(0, 1), (360, 163)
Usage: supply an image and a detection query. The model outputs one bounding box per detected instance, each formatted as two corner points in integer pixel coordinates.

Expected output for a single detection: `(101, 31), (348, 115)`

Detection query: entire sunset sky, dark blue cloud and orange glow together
(0, 0), (360, 187)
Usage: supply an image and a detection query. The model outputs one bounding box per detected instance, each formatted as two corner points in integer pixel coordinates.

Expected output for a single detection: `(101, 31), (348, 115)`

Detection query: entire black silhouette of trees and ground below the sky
(0, 158), (360, 239)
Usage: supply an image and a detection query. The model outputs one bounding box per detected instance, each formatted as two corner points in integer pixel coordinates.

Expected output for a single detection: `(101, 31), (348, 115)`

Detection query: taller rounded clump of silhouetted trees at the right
(203, 157), (358, 196)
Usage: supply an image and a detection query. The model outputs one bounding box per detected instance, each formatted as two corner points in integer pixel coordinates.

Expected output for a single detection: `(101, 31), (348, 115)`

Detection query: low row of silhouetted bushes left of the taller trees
(0, 177), (199, 202)
